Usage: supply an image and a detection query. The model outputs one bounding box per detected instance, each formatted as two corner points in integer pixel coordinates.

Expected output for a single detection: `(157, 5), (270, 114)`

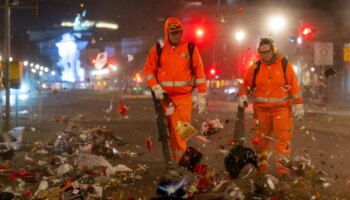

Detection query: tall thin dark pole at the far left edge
(4, 0), (11, 131)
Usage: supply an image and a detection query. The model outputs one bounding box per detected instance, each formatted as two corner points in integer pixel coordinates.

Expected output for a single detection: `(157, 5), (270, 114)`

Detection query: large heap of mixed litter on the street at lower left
(0, 118), (147, 200)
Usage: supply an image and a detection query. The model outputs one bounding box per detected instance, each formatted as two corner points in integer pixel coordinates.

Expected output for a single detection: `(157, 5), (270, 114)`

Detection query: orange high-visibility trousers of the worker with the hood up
(162, 95), (192, 160)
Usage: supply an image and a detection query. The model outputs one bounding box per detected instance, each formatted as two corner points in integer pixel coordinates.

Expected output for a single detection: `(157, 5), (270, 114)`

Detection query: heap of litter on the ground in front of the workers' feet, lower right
(153, 145), (350, 200)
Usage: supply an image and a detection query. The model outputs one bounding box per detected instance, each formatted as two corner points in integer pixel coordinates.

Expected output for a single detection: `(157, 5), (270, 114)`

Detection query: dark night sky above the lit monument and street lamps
(0, 0), (350, 36)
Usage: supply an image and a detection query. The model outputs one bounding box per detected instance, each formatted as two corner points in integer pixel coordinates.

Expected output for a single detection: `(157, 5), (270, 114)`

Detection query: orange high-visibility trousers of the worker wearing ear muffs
(254, 105), (293, 176)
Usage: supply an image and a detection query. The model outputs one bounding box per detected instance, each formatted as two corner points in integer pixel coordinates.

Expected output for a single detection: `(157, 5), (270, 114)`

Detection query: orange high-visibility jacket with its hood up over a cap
(144, 17), (206, 97)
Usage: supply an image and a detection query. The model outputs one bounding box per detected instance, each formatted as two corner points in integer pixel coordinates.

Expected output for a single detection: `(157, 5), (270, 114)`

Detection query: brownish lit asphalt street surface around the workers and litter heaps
(7, 90), (350, 197)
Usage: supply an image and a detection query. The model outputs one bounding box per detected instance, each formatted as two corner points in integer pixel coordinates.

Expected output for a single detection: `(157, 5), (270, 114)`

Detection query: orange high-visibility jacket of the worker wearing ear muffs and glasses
(239, 54), (303, 107)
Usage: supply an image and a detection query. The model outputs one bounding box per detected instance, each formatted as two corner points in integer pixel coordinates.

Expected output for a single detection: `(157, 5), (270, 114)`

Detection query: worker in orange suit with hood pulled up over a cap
(144, 17), (206, 160)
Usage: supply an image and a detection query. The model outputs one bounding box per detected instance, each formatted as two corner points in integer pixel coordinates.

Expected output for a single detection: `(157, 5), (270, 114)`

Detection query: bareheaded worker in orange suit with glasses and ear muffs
(238, 37), (304, 176)
